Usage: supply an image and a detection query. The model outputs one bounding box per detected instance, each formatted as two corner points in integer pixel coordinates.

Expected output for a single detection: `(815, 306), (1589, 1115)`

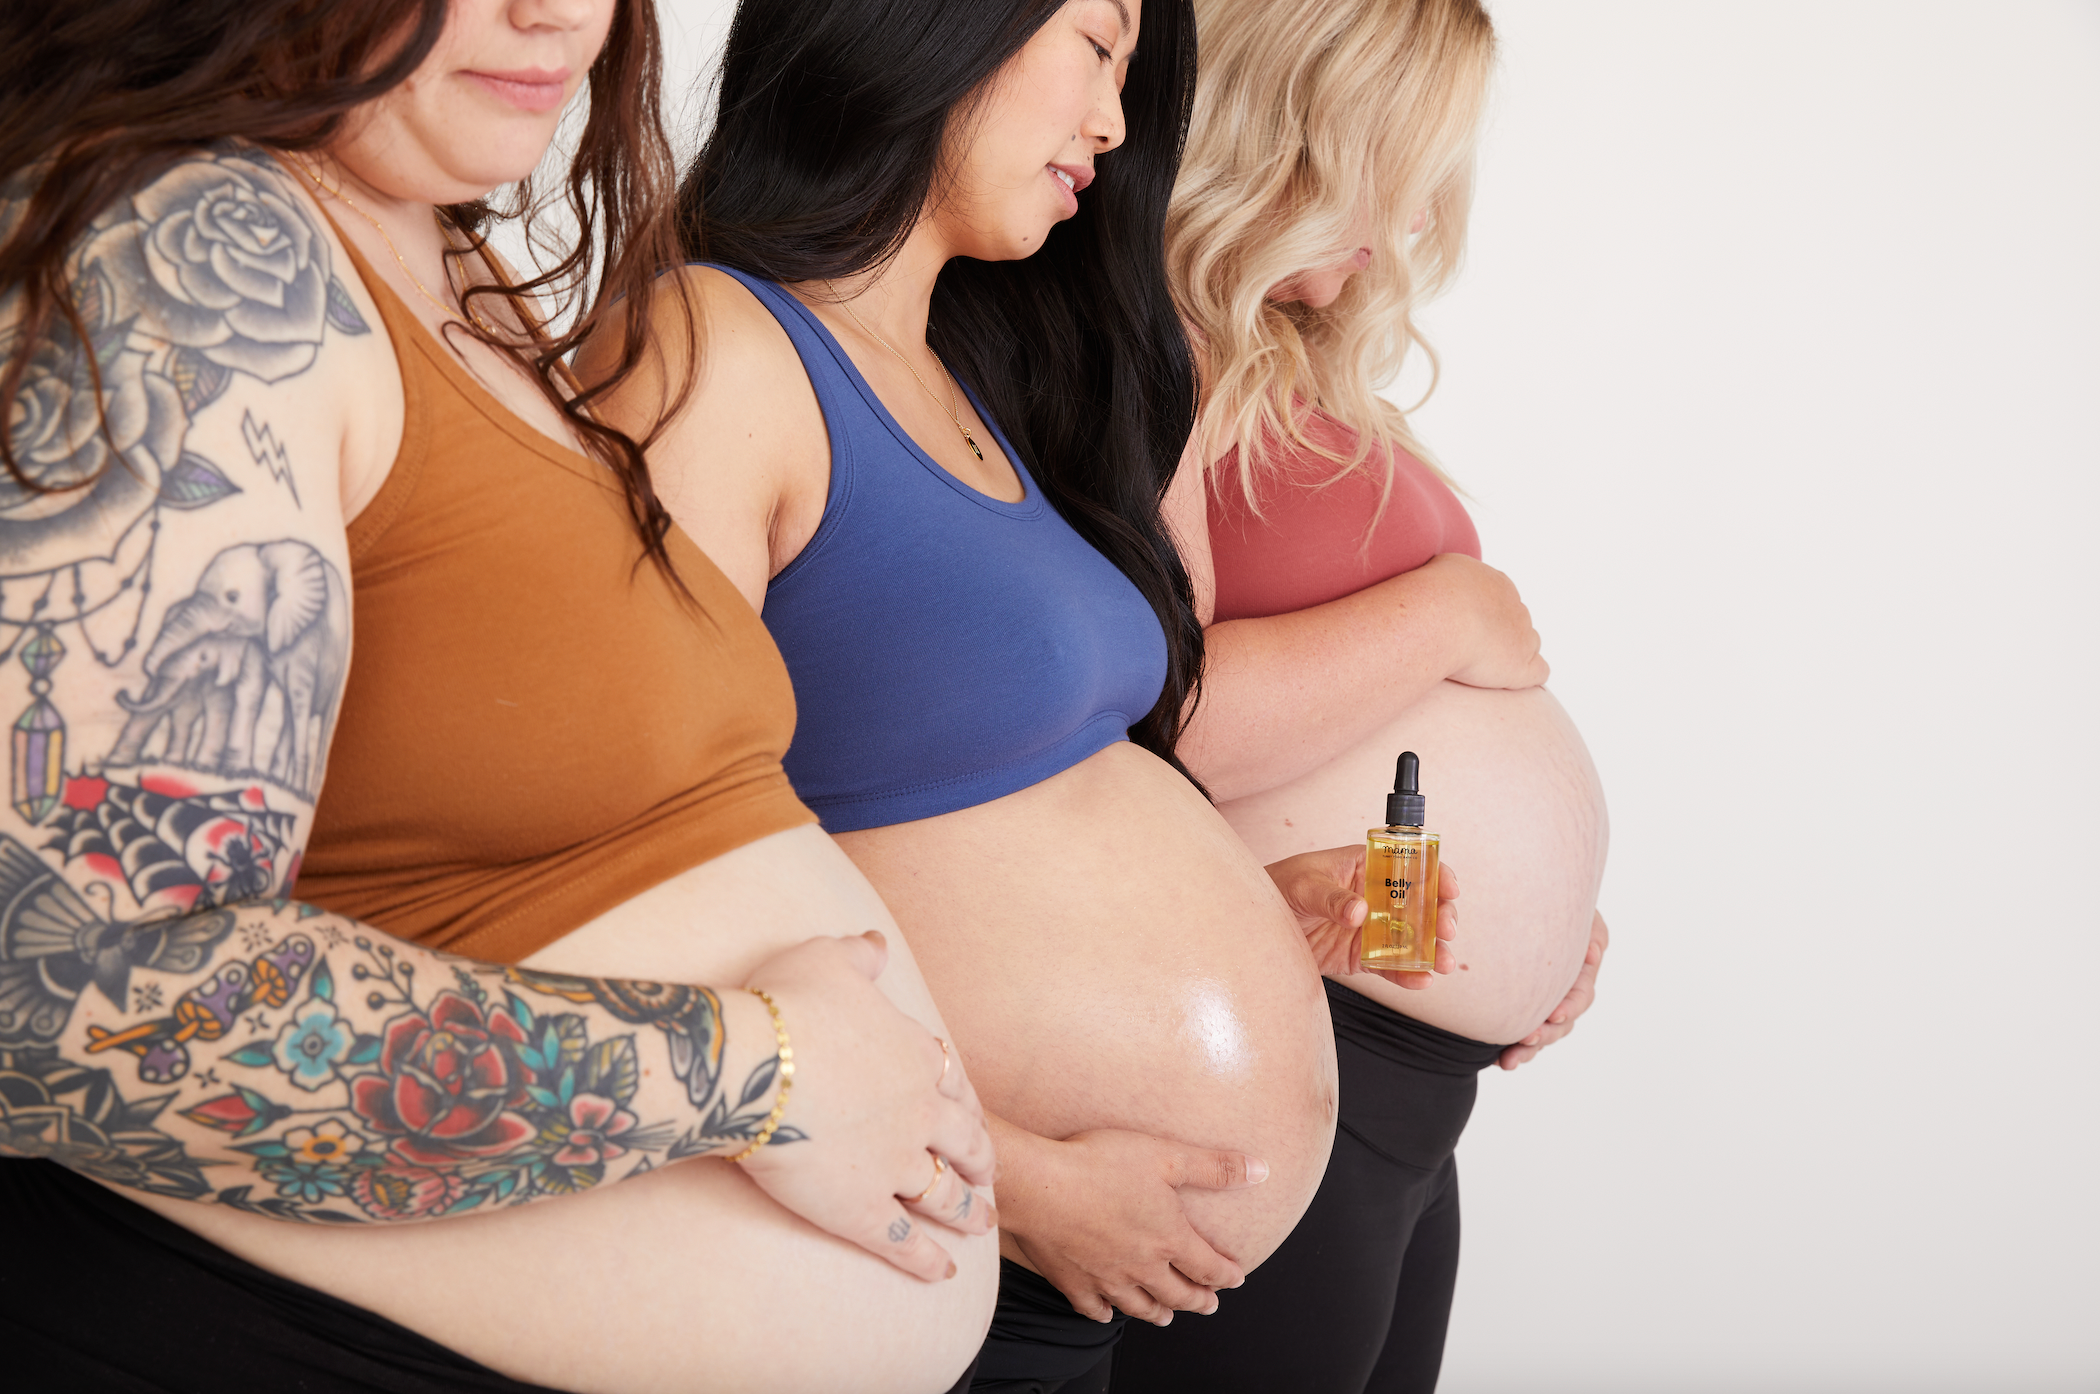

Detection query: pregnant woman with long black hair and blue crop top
(592, 0), (1334, 1394)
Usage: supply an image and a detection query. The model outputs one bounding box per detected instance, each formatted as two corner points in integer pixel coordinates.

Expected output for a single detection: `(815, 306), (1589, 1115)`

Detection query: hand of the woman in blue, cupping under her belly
(993, 1119), (1268, 1327)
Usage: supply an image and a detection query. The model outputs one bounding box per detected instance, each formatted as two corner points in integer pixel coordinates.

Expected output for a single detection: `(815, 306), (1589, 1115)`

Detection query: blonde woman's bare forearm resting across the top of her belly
(1178, 569), (1464, 802)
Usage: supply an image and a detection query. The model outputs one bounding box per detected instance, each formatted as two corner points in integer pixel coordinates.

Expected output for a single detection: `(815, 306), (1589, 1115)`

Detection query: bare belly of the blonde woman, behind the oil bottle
(1222, 682), (1609, 1043)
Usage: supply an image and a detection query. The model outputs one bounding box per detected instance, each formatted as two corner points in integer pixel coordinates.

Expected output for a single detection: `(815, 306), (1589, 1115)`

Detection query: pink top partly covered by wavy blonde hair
(1210, 411), (1481, 621)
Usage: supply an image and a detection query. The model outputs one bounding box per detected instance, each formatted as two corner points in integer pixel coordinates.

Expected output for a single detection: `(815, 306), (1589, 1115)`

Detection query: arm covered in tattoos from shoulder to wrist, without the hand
(0, 147), (796, 1222)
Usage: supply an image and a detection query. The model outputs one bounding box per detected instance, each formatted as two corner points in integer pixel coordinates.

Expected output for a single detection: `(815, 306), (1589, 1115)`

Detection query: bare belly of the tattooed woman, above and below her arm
(126, 827), (998, 1394)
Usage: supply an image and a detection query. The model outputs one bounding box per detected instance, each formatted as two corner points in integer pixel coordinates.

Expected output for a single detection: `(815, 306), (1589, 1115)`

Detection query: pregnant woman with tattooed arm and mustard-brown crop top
(0, 0), (998, 1394)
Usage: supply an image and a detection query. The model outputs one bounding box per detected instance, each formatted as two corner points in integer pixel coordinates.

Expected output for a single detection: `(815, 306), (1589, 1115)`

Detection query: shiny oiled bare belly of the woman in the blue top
(838, 743), (1336, 1266)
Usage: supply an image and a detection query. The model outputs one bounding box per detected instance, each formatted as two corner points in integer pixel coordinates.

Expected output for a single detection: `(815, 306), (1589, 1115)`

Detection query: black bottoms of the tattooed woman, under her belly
(0, 1159), (552, 1394)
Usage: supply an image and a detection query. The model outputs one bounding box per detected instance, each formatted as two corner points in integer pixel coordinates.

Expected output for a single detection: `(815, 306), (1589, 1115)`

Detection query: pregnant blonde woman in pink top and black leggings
(1115, 0), (1604, 1394)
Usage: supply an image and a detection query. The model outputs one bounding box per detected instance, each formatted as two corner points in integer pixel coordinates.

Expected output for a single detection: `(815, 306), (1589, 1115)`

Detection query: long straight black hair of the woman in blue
(678, 0), (1203, 779)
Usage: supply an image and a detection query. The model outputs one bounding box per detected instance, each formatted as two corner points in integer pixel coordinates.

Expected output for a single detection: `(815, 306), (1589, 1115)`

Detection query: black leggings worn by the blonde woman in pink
(1115, 983), (1502, 1394)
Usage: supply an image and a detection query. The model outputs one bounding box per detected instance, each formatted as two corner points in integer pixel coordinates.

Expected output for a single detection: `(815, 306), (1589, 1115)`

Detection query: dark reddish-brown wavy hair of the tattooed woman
(0, 0), (695, 579)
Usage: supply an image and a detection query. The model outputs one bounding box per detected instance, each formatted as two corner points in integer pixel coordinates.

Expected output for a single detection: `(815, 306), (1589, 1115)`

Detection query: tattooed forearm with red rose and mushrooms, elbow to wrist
(14, 901), (800, 1224)
